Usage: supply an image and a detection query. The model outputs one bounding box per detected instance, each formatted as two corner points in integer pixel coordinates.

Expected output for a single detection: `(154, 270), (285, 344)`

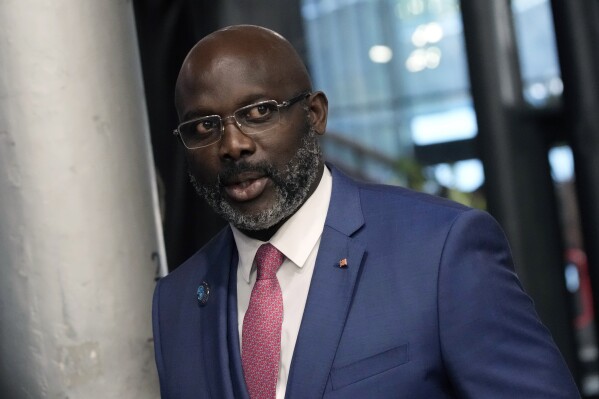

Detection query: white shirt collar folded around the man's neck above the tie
(231, 166), (333, 283)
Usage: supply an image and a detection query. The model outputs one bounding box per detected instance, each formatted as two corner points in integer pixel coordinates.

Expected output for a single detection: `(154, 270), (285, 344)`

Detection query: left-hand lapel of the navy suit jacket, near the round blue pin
(198, 229), (239, 398)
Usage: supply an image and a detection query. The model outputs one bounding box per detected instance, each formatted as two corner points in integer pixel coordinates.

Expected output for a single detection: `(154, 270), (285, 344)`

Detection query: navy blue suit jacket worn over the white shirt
(153, 168), (579, 399)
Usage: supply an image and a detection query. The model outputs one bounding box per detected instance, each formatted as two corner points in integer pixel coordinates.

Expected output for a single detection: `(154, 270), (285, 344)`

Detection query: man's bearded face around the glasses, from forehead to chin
(178, 52), (322, 231)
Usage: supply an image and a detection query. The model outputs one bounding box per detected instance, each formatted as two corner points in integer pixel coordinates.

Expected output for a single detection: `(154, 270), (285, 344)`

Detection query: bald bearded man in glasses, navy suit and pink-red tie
(153, 26), (578, 399)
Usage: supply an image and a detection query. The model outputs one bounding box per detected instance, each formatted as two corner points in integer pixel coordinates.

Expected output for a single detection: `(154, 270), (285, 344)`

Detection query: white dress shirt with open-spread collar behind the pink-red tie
(231, 167), (333, 399)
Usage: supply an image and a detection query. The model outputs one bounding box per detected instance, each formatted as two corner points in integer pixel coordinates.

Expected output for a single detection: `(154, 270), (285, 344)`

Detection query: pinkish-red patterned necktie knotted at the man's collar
(241, 243), (285, 399)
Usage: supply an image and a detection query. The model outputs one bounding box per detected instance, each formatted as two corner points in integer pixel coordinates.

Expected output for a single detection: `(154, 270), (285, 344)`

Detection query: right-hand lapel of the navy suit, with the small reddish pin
(285, 168), (366, 399)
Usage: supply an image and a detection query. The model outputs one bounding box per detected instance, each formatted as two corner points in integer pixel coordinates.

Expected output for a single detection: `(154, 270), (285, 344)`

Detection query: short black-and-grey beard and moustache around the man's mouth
(189, 129), (322, 231)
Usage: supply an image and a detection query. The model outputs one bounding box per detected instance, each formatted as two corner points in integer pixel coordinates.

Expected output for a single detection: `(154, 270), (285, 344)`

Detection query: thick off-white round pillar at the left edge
(0, 0), (168, 399)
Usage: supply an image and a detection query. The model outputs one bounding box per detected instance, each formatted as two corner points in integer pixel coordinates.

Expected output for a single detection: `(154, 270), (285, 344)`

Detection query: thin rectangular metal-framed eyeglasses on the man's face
(173, 92), (310, 150)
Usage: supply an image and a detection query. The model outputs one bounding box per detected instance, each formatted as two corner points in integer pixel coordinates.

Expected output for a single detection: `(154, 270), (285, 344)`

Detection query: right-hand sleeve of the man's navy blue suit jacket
(438, 210), (580, 399)
